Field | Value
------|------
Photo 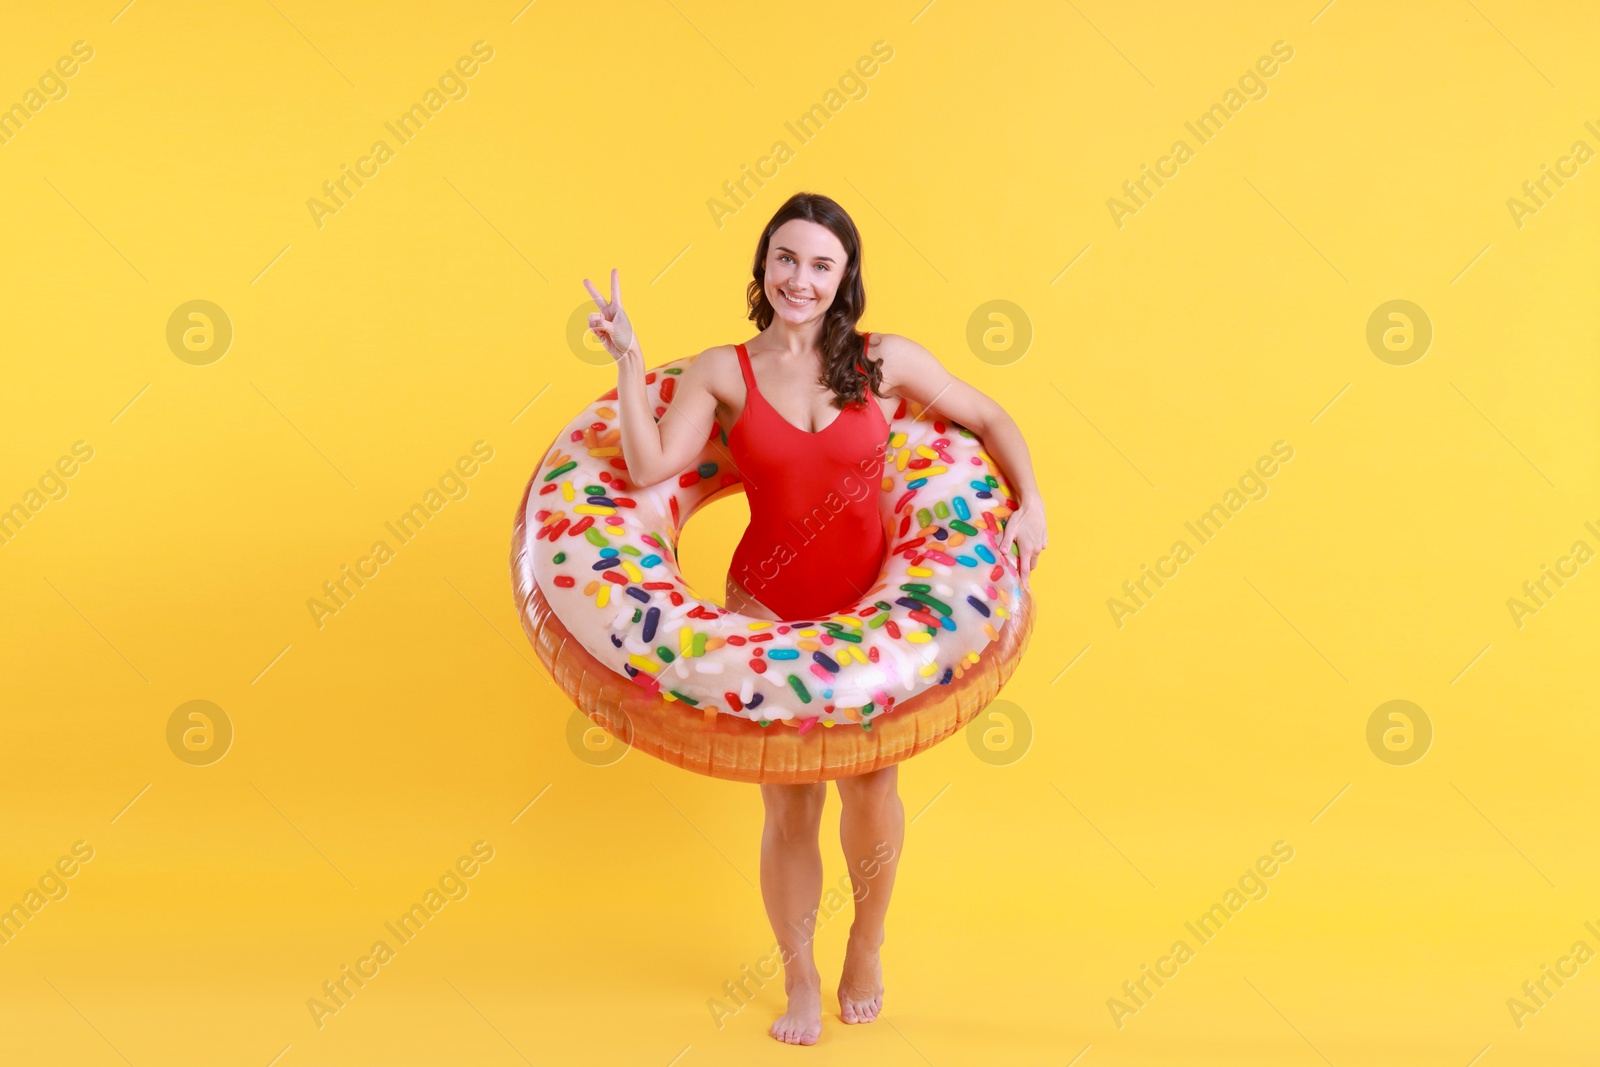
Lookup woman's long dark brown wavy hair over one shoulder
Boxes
[746,192,883,408]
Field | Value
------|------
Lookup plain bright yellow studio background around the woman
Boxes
[0,0,1600,1067]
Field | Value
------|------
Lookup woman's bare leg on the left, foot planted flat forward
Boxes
[762,782,827,1045]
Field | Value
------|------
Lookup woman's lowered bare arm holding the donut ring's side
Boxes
[874,333,1050,587]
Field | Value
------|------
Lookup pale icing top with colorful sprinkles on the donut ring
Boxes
[525,360,1021,734]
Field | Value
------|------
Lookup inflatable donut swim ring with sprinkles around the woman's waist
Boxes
[510,360,1034,784]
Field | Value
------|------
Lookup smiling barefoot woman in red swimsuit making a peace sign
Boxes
[584,194,1048,1045]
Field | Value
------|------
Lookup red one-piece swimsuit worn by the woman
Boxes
[728,334,890,622]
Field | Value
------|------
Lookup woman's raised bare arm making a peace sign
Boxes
[584,269,717,486]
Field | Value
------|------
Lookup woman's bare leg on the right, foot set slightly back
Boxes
[838,763,906,1022]
